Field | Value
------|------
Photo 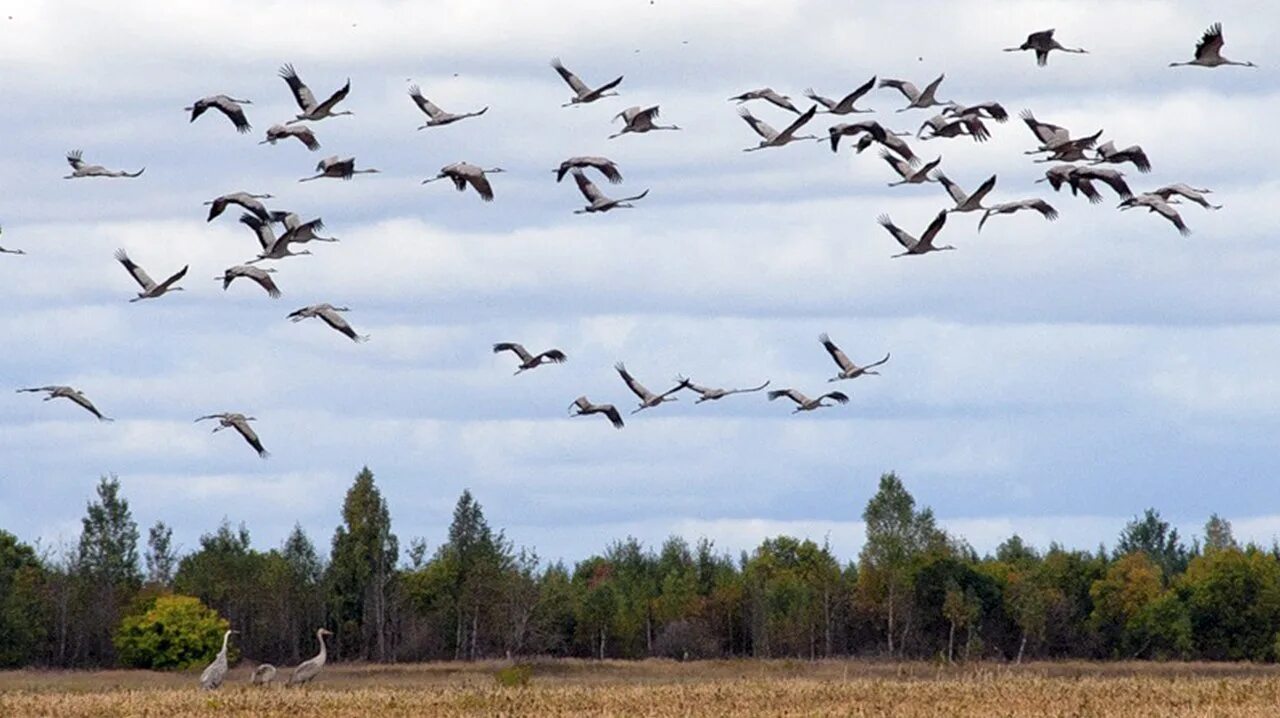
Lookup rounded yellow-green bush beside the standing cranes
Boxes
[114,595,229,669]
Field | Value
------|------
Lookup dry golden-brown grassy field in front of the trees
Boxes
[0,660,1280,718]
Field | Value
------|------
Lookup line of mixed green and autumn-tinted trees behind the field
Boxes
[0,468,1280,667]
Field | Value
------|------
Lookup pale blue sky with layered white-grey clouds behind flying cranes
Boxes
[0,0,1280,559]
